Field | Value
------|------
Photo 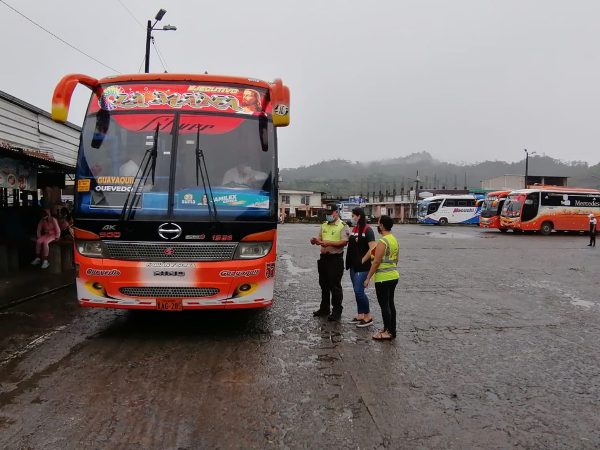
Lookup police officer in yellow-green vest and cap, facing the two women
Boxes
[310,205,350,321]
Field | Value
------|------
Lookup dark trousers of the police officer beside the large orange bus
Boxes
[317,253,344,315]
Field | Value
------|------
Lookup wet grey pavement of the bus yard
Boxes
[0,225,600,449]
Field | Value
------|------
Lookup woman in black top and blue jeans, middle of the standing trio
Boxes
[346,208,377,328]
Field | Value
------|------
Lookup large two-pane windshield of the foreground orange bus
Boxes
[76,82,276,220]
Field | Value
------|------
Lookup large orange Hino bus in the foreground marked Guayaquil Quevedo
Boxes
[52,73,289,311]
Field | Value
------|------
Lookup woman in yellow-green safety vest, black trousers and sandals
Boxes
[364,216,400,341]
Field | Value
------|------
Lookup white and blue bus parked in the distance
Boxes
[418,194,479,225]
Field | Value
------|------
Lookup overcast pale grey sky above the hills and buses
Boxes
[0,0,600,167]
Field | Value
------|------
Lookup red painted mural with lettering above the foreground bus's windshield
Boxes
[90,84,266,114]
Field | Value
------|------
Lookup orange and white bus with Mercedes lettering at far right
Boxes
[500,186,600,235]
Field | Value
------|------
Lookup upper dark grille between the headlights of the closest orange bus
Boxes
[103,241,237,261]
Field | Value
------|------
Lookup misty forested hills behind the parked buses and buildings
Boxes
[280,152,600,196]
